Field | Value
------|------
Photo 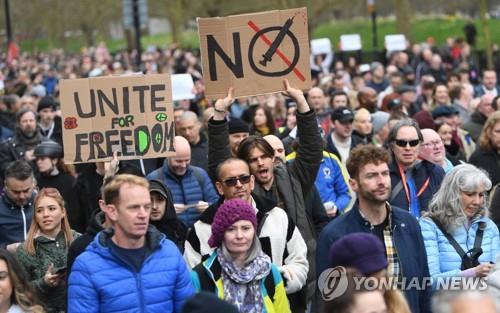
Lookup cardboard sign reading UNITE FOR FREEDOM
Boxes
[60,74,175,163]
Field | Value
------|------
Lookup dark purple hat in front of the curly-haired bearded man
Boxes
[329,233,387,275]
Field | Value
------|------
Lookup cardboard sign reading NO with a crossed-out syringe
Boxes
[198,8,311,99]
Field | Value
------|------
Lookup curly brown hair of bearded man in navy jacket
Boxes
[347,145,391,178]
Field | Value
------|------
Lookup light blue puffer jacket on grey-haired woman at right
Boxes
[420,216,500,279]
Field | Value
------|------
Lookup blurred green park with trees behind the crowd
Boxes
[0,0,500,67]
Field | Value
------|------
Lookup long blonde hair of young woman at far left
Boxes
[24,188,73,255]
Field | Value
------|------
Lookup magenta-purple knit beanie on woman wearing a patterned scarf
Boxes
[208,199,257,248]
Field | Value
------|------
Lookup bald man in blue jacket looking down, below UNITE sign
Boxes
[147,136,219,227]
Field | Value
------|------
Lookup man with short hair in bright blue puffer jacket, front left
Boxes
[68,174,194,313]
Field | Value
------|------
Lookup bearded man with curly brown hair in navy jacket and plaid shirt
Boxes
[316,145,430,313]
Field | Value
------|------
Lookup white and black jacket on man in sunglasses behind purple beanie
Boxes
[184,196,309,293]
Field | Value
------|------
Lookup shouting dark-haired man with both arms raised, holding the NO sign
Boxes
[208,80,323,312]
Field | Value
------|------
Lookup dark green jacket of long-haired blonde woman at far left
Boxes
[16,231,79,312]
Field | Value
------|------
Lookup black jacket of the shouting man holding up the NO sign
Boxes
[208,110,327,302]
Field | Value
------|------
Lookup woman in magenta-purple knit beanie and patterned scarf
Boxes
[191,199,290,313]
